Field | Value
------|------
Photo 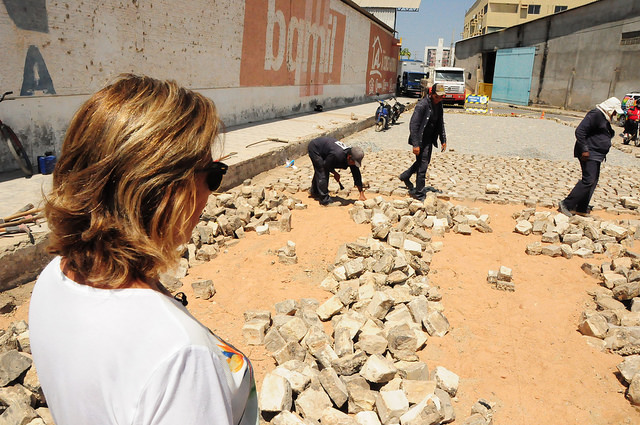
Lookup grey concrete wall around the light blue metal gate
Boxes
[455,0,640,110]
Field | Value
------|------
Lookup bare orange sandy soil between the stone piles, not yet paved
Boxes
[5,193,640,425]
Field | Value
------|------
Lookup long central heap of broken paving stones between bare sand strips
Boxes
[243,194,494,425]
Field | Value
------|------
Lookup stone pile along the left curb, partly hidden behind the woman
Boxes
[0,180,304,425]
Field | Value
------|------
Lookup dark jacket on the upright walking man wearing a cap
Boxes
[409,95,447,147]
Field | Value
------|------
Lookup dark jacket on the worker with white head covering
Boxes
[573,109,615,162]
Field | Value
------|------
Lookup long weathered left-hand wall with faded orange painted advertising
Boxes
[0,0,398,172]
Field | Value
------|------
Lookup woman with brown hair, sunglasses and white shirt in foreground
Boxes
[29,75,258,425]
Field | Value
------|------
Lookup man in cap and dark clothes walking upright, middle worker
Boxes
[400,83,447,201]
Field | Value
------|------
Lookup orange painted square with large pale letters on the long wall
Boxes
[240,0,346,97]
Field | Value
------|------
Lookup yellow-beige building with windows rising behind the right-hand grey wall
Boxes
[462,0,597,39]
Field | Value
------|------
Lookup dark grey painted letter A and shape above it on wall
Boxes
[2,0,56,96]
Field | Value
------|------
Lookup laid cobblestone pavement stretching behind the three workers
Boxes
[314,111,640,213]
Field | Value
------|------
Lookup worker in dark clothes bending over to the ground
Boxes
[309,136,367,205]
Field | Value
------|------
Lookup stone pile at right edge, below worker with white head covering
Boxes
[514,209,640,405]
